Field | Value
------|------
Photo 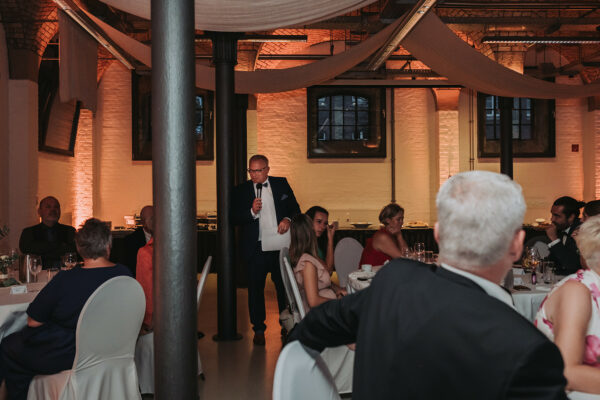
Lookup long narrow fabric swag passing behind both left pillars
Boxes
[88,10,400,93]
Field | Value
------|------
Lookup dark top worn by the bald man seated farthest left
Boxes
[19,223,77,268]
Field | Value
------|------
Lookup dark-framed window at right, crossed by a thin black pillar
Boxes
[477,93,555,158]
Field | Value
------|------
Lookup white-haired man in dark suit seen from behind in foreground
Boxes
[290,171,566,400]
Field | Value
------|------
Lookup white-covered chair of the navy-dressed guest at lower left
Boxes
[27,276,146,400]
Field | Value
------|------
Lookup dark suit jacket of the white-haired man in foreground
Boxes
[290,260,566,400]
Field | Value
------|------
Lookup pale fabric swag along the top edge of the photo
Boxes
[101,0,375,32]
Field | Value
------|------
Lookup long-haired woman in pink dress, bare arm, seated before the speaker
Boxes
[290,214,346,311]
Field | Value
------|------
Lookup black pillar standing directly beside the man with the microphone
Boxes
[211,32,241,340]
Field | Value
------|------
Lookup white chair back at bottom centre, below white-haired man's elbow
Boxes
[273,341,340,400]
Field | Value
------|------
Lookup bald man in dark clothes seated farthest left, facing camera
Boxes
[19,196,76,268]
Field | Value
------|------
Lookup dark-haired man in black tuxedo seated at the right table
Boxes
[546,196,585,275]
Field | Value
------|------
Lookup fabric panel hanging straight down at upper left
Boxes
[58,10,98,112]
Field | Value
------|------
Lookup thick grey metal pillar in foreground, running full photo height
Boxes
[152,0,198,400]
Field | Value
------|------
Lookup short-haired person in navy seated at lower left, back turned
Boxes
[0,218,131,400]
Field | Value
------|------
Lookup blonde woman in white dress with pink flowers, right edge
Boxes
[534,216,600,393]
